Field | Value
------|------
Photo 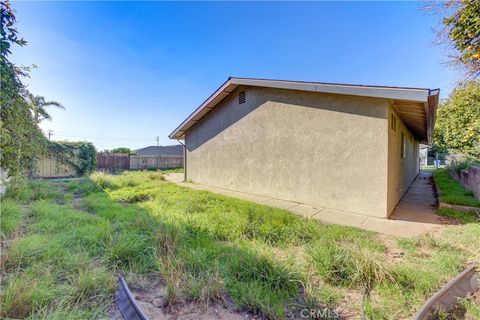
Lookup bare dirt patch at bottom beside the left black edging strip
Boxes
[108,277,256,320]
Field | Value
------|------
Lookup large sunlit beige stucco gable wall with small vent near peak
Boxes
[185,87,389,217]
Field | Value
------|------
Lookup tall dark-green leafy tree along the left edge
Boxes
[0,1,46,175]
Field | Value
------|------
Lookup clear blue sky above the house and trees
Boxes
[12,2,459,150]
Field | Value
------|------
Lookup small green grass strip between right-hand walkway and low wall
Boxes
[433,169,480,207]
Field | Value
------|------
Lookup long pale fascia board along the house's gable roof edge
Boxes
[169,77,431,140]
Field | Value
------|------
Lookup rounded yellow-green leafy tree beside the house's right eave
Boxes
[434,81,480,159]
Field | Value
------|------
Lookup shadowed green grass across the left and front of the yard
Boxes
[1,179,330,319]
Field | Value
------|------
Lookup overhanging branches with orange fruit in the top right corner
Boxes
[429,0,480,79]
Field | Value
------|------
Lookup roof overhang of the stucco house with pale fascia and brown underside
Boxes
[169,78,439,143]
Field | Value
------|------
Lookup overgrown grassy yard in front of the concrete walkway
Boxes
[0,172,480,319]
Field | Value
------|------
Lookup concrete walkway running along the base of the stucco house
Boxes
[165,173,441,237]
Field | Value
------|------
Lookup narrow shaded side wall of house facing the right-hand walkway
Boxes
[387,106,420,215]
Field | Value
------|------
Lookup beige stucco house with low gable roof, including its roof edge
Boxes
[170,78,439,218]
